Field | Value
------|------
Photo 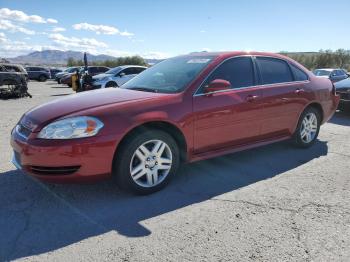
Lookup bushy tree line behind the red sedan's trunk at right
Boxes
[280,49,350,71]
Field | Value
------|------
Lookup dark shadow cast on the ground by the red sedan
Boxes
[0,141,328,260]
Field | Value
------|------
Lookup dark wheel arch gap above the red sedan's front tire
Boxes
[113,120,188,165]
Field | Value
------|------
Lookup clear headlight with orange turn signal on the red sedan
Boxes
[38,116,103,139]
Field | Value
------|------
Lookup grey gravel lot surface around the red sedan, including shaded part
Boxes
[0,82,350,261]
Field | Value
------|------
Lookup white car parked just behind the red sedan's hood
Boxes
[92,65,147,89]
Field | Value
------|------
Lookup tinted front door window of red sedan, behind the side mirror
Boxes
[204,57,254,89]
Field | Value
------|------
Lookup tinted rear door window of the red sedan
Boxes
[256,57,293,85]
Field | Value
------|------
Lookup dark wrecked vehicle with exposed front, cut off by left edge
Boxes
[0,63,31,98]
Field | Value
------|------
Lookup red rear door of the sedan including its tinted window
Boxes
[255,56,308,138]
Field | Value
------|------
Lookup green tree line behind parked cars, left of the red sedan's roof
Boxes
[67,56,147,68]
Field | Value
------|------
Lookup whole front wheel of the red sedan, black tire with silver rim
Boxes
[113,130,180,195]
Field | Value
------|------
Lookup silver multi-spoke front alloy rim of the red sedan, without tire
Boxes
[130,140,172,187]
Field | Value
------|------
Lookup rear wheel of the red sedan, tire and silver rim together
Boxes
[293,107,321,148]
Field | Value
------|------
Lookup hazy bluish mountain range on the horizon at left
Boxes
[6,50,160,65]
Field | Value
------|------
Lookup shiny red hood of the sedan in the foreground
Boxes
[21,88,164,132]
